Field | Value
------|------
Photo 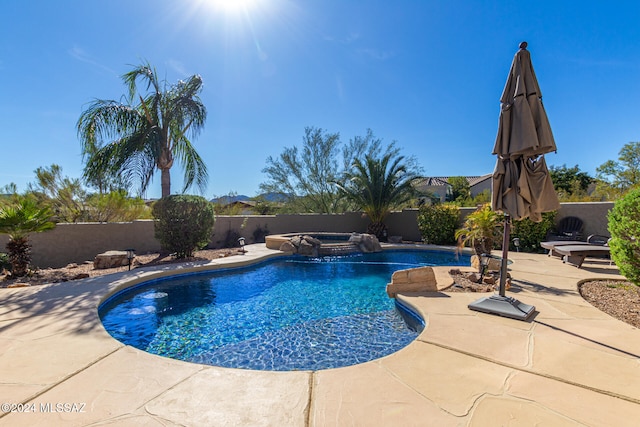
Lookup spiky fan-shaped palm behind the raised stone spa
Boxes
[337,150,417,240]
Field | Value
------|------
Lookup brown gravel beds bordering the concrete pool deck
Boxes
[0,249,640,328]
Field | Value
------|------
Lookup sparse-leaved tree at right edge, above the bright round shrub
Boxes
[596,142,640,198]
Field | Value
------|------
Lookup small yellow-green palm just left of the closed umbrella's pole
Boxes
[455,204,502,256]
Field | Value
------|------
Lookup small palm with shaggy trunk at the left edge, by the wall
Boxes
[0,198,56,277]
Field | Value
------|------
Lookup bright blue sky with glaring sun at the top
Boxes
[0,0,640,198]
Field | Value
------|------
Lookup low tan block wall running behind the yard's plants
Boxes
[0,202,613,268]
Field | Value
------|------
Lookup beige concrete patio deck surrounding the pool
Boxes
[0,245,640,427]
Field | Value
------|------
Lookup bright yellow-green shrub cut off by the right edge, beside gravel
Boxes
[608,189,640,285]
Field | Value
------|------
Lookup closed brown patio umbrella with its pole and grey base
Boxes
[469,42,560,320]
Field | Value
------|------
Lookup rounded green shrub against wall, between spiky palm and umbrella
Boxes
[418,204,460,245]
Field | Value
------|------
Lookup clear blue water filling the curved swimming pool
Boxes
[99,251,469,371]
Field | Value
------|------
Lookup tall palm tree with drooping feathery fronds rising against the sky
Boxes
[77,63,208,197]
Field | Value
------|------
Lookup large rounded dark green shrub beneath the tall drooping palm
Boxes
[153,195,215,258]
